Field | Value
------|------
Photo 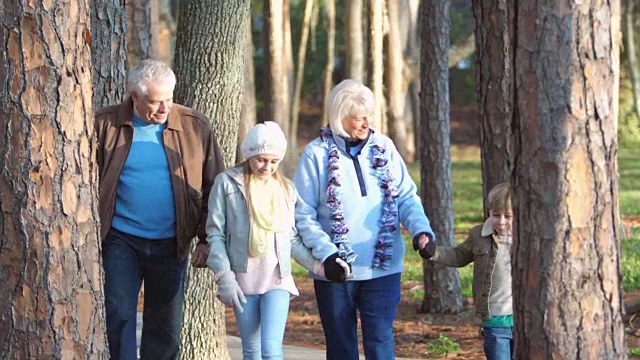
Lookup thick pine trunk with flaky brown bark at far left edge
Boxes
[0,0,108,359]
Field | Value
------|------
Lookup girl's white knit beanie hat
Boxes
[240,121,287,160]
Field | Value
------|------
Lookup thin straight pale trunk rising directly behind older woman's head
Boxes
[368,0,387,133]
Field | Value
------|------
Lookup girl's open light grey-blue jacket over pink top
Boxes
[207,163,316,277]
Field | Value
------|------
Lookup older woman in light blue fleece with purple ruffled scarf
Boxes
[294,80,435,360]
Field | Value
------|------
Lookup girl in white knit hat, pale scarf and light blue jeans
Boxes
[207,121,348,360]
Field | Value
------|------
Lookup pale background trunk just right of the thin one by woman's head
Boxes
[385,1,413,161]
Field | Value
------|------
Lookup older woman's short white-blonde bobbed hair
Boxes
[325,79,375,138]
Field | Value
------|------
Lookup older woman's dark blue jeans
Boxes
[314,273,401,360]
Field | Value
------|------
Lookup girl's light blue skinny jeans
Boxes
[234,289,291,360]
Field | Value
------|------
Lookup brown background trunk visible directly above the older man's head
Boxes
[125,0,159,69]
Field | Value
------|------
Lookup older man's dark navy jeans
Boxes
[102,228,186,360]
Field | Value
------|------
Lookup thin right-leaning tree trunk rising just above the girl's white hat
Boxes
[289,0,315,155]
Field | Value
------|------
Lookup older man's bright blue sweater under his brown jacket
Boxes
[111,115,176,239]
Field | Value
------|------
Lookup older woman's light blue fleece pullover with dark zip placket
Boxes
[293,131,435,281]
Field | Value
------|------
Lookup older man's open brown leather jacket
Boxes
[95,98,224,259]
